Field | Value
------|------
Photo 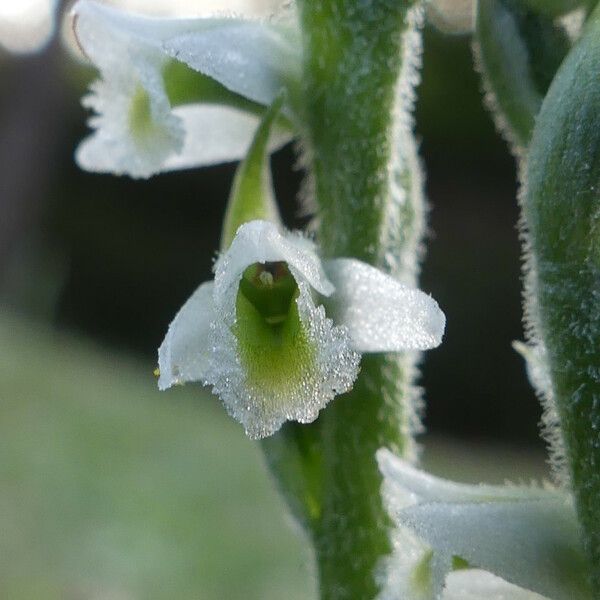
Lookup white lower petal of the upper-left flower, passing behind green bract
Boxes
[163,104,291,171]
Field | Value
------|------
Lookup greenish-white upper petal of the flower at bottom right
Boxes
[377,450,586,600]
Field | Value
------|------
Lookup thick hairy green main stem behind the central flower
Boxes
[300,0,423,599]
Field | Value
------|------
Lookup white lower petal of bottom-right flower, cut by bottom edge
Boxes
[442,569,547,600]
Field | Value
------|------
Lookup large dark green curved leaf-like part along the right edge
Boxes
[523,7,600,597]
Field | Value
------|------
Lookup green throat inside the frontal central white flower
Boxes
[233,262,315,395]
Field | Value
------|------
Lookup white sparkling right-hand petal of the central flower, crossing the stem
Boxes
[326,258,446,352]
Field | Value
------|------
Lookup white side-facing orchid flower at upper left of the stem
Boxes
[73,0,300,177]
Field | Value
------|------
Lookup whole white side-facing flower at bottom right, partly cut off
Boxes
[377,449,590,600]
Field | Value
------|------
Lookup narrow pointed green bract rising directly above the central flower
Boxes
[221,95,283,250]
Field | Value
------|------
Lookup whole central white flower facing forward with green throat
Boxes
[158,221,445,438]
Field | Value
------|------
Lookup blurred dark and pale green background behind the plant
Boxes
[0,17,545,600]
